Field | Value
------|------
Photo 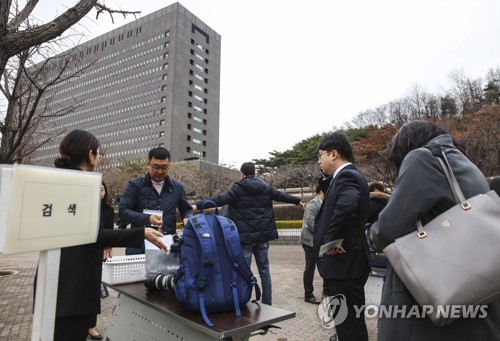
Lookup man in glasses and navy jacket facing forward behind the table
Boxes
[119,147,193,255]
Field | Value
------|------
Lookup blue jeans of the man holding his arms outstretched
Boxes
[241,242,272,305]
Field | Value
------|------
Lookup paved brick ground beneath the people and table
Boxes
[0,245,377,341]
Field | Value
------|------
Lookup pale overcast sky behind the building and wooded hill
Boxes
[35,0,500,167]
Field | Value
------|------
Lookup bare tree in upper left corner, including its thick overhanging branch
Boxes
[0,0,140,163]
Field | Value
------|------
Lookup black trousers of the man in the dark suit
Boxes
[327,276,368,341]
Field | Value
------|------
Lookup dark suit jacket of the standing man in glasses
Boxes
[314,164,370,280]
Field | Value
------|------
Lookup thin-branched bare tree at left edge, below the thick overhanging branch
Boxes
[0,41,97,163]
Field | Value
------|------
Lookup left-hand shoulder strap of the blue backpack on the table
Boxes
[189,214,217,327]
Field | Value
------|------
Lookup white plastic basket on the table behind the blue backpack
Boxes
[102,255,146,284]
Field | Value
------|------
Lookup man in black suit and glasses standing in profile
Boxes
[314,133,370,341]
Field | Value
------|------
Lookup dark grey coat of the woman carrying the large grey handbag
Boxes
[371,135,500,341]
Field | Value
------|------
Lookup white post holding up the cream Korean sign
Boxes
[31,249,61,341]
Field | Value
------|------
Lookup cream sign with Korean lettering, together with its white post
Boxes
[0,165,102,341]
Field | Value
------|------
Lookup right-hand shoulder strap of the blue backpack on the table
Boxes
[216,215,261,310]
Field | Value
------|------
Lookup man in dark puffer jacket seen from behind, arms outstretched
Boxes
[196,162,304,305]
